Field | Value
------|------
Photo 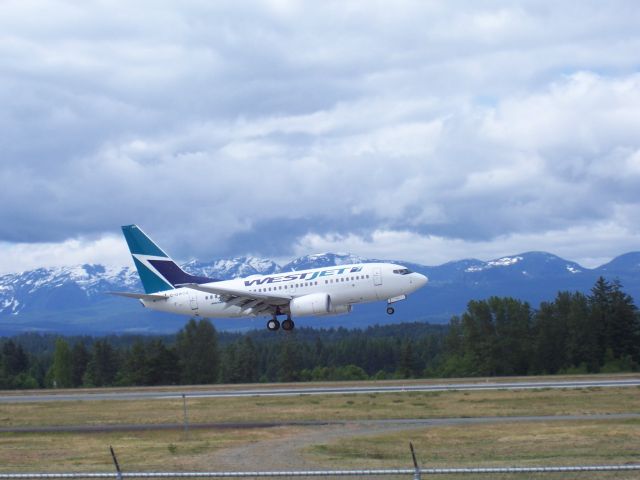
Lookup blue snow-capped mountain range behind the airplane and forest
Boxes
[0,252,640,335]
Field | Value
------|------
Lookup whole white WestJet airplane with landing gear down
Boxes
[110,225,428,331]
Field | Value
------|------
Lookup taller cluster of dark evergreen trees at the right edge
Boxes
[434,277,640,376]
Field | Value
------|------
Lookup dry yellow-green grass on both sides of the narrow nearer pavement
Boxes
[0,376,640,479]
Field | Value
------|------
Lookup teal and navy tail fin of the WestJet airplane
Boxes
[122,225,216,294]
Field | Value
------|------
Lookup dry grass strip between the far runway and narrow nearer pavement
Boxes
[0,387,640,427]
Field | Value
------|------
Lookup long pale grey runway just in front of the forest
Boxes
[0,378,640,403]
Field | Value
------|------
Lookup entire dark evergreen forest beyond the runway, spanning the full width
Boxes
[0,278,640,389]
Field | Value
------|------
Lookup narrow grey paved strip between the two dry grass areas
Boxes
[0,413,640,433]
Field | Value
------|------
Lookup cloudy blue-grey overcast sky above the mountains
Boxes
[0,0,640,273]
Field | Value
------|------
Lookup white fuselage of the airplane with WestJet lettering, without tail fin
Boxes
[140,263,427,318]
